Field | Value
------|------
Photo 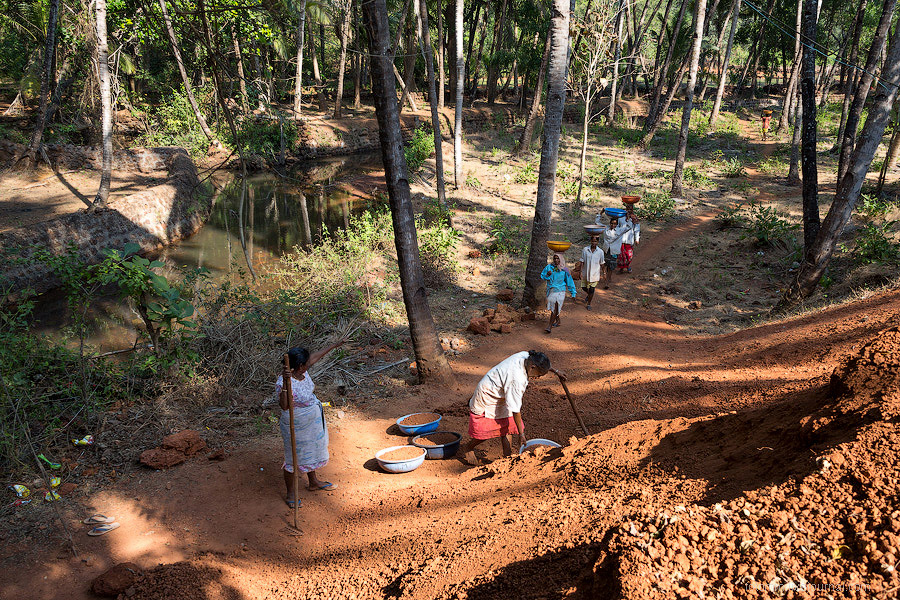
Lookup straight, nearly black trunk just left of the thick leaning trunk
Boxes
[800,0,821,252]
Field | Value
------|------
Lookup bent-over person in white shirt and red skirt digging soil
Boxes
[461,350,550,466]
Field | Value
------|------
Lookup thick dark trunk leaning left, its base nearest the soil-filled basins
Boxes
[363,0,453,383]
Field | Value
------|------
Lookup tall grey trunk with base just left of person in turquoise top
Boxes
[522,0,570,308]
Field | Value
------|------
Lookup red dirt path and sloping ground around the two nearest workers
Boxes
[0,215,900,600]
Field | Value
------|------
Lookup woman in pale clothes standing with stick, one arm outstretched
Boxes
[275,340,345,508]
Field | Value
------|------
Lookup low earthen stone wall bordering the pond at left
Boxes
[0,148,212,293]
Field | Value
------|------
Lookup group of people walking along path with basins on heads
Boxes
[541,208,641,333]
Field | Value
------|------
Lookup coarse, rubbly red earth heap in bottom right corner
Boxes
[595,329,900,598]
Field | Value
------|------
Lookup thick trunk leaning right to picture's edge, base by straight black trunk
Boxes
[776,22,900,310]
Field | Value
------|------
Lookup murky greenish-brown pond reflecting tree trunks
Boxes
[27,154,384,352]
